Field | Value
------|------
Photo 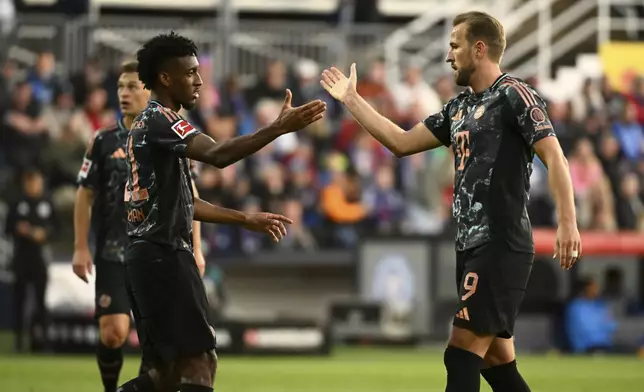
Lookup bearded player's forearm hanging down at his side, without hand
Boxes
[548,155,577,224]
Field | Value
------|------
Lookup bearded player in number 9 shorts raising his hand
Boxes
[320,12,581,392]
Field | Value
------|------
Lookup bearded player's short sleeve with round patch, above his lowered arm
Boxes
[506,81,555,148]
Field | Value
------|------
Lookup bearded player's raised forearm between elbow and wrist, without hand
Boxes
[344,89,405,155]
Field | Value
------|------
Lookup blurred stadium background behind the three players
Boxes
[0,0,644,392]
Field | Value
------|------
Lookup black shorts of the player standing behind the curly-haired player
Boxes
[94,259,130,320]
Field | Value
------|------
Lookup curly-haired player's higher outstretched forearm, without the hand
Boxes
[206,127,282,169]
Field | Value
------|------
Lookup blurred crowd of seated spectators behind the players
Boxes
[0,52,644,254]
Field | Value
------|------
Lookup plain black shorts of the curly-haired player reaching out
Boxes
[125,240,216,366]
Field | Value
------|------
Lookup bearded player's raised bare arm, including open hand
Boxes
[320,64,449,157]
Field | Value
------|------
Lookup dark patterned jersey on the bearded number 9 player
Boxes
[423,74,555,253]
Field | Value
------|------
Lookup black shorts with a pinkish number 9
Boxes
[453,242,534,339]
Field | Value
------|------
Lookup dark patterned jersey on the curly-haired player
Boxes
[125,101,199,252]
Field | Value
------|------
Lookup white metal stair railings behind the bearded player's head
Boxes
[385,0,644,82]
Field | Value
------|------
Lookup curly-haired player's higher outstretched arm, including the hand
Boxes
[185,90,326,169]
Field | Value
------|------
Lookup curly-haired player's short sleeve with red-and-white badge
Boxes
[146,109,200,156]
